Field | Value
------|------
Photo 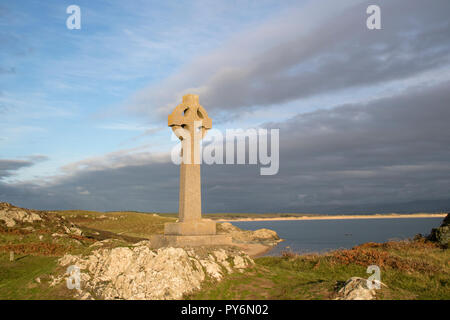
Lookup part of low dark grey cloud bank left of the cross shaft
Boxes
[0,163,178,212]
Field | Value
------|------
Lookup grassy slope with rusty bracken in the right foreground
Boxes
[186,241,450,300]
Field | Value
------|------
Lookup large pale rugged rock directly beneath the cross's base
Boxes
[53,241,254,299]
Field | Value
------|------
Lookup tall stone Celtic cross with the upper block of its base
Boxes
[164,94,216,235]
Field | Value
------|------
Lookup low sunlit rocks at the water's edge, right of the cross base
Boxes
[217,222,282,246]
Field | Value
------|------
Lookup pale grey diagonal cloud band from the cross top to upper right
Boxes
[128,0,450,120]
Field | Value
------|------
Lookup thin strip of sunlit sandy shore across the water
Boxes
[214,213,447,222]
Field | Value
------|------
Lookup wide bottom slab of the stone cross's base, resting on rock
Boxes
[150,234,232,248]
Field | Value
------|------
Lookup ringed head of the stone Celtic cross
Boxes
[168,94,212,140]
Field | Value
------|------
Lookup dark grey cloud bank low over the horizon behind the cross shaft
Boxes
[0,82,450,213]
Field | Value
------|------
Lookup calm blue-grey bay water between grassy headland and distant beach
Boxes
[233,218,442,255]
